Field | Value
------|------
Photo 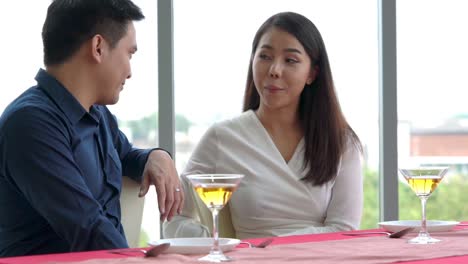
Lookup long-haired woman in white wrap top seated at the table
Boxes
[165,12,363,239]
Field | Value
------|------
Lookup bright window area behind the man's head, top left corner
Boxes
[0,0,50,112]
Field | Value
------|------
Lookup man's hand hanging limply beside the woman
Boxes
[139,150,184,221]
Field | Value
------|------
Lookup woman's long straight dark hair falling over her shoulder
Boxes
[243,12,362,185]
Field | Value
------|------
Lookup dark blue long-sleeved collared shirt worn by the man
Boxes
[0,69,151,256]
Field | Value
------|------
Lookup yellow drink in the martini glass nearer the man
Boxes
[195,183,237,209]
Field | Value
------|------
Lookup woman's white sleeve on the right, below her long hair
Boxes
[282,140,363,236]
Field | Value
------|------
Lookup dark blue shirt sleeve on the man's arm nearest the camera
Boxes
[4,107,128,251]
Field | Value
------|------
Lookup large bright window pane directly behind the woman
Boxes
[174,0,379,228]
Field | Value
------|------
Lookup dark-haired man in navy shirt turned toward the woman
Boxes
[0,0,184,256]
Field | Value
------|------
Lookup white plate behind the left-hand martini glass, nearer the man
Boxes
[148,237,240,254]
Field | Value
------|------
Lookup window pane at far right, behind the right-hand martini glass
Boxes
[397,0,468,220]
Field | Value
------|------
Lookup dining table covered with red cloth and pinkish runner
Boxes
[0,222,468,264]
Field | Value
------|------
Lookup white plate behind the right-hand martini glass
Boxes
[379,220,460,233]
